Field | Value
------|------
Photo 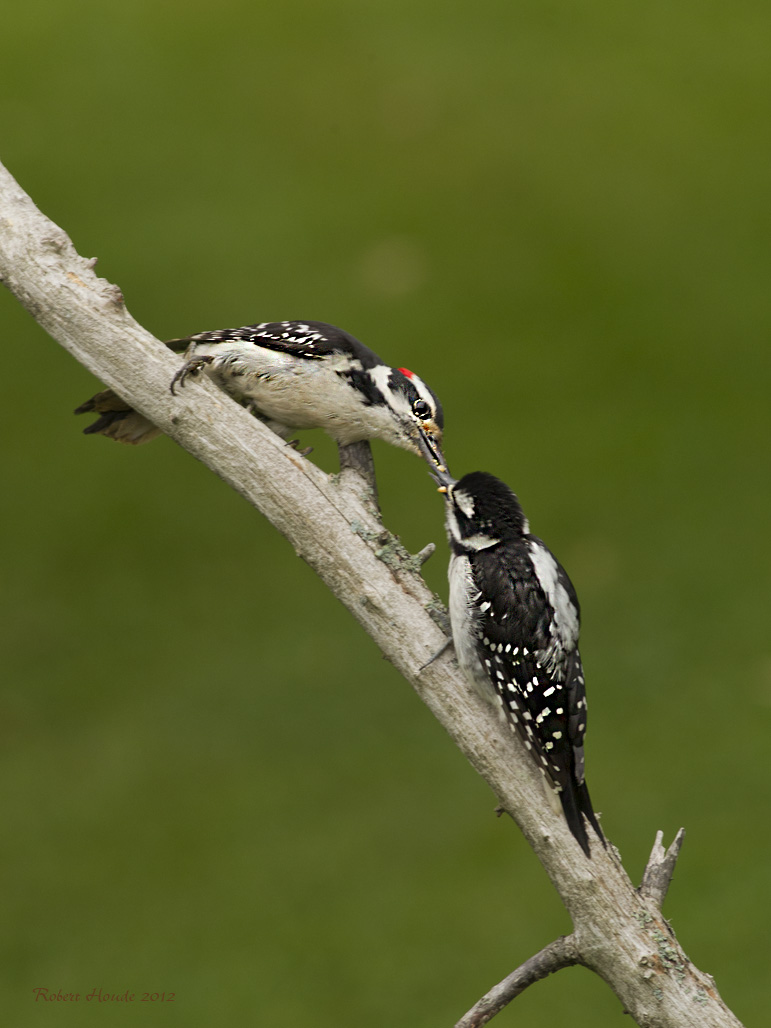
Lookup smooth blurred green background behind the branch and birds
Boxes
[0,0,771,1028]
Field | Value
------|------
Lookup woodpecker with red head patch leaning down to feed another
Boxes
[75,321,444,464]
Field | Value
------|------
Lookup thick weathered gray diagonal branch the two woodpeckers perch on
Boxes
[0,154,739,1028]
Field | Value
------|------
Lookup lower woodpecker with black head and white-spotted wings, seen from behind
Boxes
[434,471,604,857]
